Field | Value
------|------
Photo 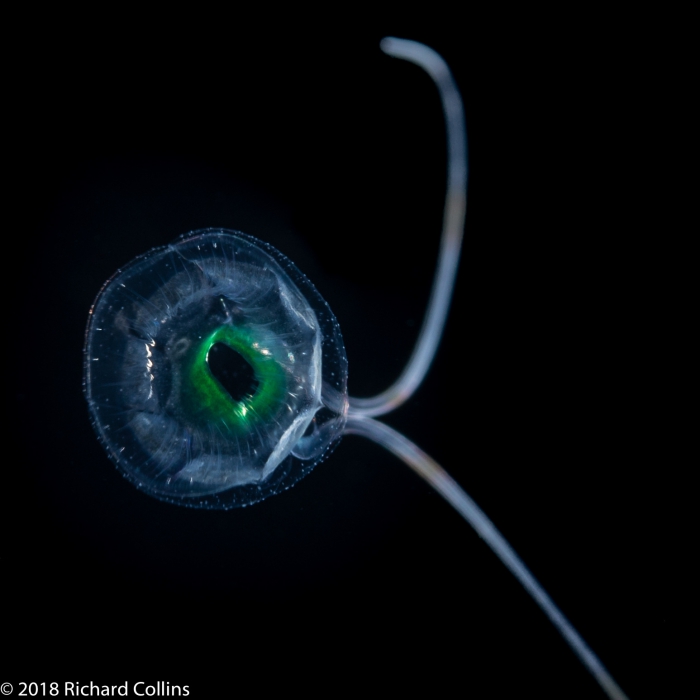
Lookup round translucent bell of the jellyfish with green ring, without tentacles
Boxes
[84,229,348,508]
